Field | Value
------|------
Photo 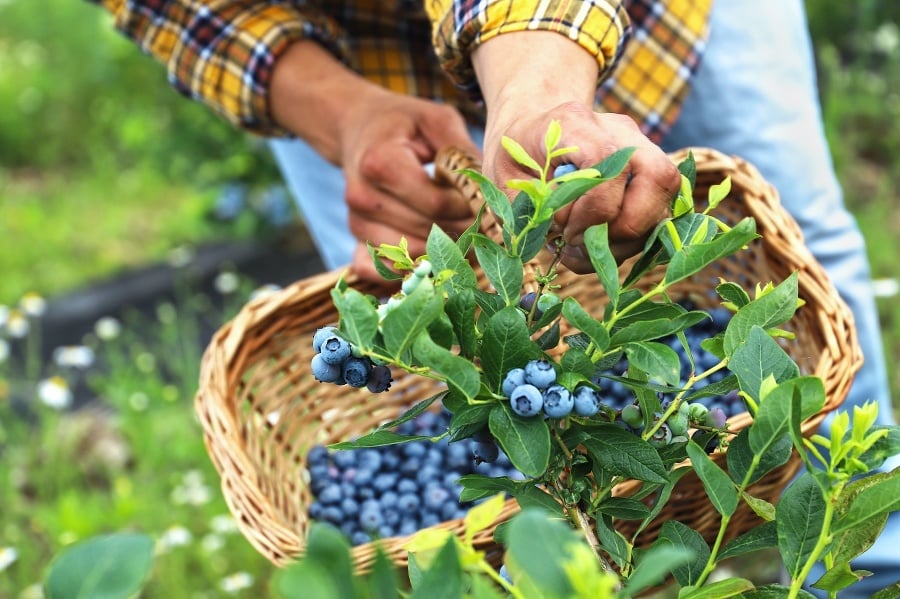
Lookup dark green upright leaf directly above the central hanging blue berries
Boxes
[480,307,540,391]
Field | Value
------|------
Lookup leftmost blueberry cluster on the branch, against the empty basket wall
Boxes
[310,326,391,393]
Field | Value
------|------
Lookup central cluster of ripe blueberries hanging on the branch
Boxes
[501,359,600,418]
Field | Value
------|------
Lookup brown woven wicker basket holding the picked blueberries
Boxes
[196,148,862,571]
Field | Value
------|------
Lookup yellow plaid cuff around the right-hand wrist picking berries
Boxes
[426,0,628,95]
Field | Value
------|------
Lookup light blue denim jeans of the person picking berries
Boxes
[271,0,900,597]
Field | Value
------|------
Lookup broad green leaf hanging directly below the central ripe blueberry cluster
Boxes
[488,402,548,478]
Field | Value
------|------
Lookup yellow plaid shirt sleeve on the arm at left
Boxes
[85,0,348,135]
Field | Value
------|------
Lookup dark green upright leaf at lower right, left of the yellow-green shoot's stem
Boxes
[775,472,825,579]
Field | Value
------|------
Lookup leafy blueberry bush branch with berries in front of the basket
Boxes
[312,122,900,597]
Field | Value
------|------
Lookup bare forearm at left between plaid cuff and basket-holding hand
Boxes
[269,40,388,164]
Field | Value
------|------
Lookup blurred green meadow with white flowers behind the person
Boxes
[0,0,900,597]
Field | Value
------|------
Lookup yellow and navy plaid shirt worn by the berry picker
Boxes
[89,0,712,141]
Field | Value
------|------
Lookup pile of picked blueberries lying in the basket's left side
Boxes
[307,412,522,545]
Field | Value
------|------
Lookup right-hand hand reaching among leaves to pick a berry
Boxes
[483,102,681,273]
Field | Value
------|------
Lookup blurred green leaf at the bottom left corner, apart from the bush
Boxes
[44,533,153,599]
